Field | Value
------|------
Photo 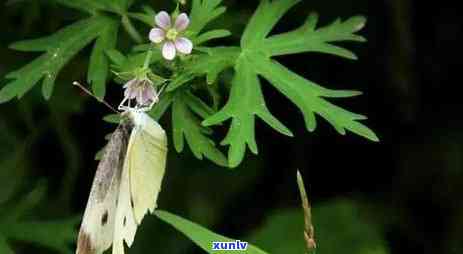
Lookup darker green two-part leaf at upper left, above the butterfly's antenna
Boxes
[0,16,117,102]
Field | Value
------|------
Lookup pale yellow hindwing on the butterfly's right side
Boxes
[128,113,167,224]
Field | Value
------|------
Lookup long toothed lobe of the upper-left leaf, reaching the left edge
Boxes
[0,16,118,103]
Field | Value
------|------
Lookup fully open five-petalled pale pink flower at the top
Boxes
[149,11,193,60]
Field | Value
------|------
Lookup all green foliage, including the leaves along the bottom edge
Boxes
[0,0,385,251]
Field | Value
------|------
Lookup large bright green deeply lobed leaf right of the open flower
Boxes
[205,0,379,167]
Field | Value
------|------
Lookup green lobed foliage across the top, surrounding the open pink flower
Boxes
[0,0,378,167]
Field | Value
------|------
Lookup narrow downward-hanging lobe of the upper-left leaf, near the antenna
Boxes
[87,18,119,99]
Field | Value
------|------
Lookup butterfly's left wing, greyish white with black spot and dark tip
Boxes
[76,125,129,254]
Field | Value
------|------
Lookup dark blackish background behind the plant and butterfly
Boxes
[0,0,463,254]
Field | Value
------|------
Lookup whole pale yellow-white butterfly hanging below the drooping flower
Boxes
[76,81,167,254]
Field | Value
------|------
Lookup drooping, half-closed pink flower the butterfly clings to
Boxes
[124,78,158,107]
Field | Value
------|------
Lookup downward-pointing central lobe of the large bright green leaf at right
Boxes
[203,58,293,167]
